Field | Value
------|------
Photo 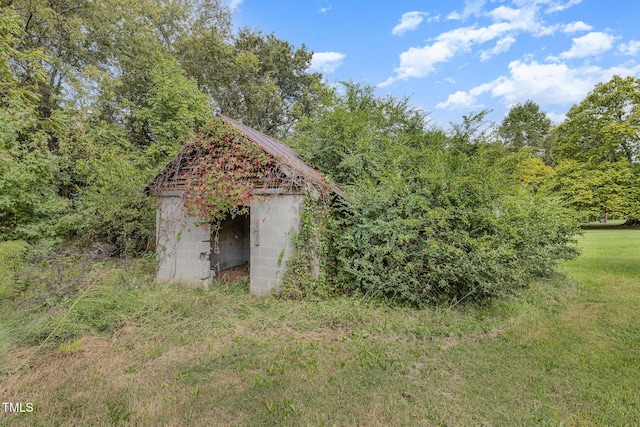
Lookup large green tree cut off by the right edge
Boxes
[552,76,640,224]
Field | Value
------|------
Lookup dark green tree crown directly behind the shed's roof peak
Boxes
[177,28,324,137]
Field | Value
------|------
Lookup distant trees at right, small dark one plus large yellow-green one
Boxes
[498,76,640,226]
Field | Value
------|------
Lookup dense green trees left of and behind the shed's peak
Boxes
[0,0,323,254]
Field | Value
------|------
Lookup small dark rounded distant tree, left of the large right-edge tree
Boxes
[498,100,551,160]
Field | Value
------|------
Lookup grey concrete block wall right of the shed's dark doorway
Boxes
[250,195,304,295]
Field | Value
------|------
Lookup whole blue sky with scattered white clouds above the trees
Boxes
[230,0,640,127]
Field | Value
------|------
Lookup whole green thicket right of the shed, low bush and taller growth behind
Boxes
[298,85,576,306]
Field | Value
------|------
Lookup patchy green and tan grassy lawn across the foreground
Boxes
[0,229,640,426]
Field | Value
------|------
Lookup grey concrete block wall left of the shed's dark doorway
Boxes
[156,196,211,286]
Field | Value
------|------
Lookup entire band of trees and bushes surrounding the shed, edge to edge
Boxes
[0,0,640,305]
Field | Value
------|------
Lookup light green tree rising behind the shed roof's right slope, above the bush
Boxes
[291,83,432,185]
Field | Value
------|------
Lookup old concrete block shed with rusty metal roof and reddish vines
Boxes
[145,114,343,295]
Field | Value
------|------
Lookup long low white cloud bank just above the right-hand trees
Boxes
[436,61,640,113]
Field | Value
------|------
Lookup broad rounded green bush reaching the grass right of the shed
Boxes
[334,150,577,307]
